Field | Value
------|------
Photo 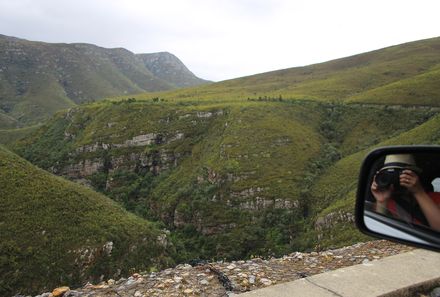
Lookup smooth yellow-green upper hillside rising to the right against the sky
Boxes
[130,38,440,106]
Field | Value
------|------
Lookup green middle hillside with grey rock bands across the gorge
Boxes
[15,100,435,261]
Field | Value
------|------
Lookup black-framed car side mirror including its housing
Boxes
[355,146,440,251]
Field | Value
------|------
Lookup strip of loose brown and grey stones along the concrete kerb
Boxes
[33,240,412,297]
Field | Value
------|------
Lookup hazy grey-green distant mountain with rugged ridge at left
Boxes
[0,35,207,127]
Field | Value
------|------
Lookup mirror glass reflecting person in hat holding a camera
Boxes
[364,153,440,246]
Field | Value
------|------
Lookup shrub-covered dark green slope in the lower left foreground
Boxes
[0,146,170,296]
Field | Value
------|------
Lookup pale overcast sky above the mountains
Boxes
[0,0,440,81]
